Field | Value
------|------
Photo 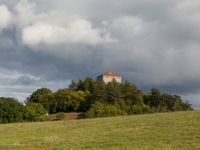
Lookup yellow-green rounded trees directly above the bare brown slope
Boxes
[38,89,92,113]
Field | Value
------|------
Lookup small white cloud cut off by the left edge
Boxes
[0,5,12,31]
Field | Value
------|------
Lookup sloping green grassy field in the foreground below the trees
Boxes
[0,110,200,150]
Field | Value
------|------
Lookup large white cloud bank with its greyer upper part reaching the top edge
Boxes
[10,0,118,47]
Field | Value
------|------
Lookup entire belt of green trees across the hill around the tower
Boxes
[0,77,192,123]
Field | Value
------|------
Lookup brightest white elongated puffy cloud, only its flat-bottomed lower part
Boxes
[22,19,117,46]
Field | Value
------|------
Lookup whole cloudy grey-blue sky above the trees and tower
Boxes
[0,0,200,109]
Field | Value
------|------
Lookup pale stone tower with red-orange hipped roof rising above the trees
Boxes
[97,71,122,83]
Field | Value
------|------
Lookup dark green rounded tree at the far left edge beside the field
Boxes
[0,97,24,123]
